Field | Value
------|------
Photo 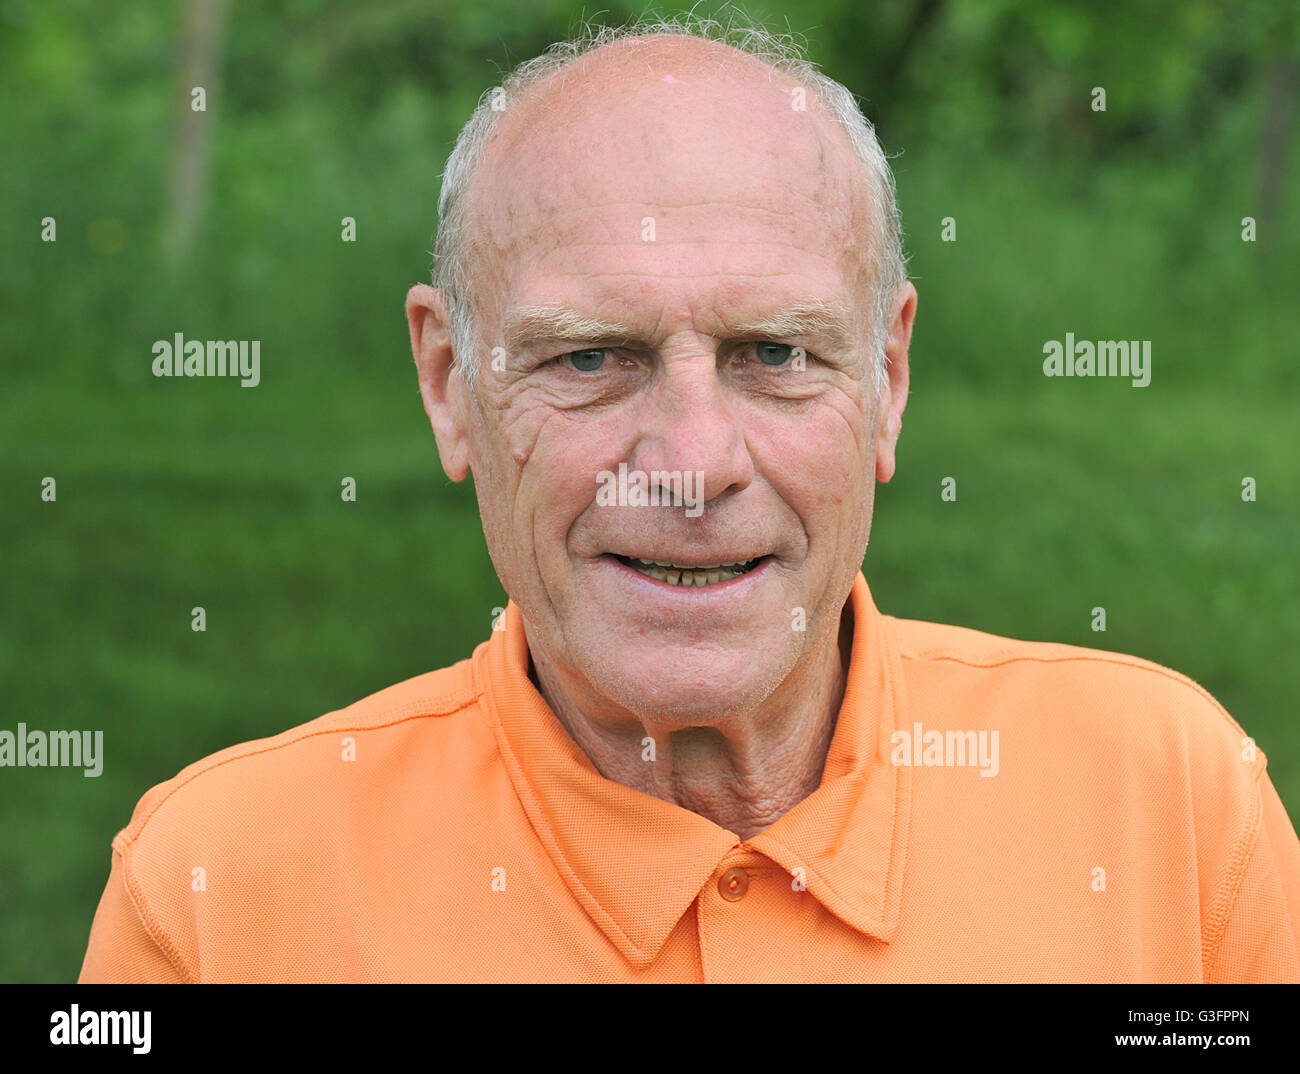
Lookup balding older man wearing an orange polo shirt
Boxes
[82,26,1300,982]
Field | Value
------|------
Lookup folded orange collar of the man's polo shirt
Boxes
[473,572,911,969]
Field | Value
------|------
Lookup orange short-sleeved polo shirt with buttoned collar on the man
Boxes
[81,575,1300,982]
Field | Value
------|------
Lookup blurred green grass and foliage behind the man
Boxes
[0,0,1300,980]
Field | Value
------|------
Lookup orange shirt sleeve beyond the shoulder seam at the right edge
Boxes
[1206,771,1300,983]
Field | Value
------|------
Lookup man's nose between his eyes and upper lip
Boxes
[628,346,754,504]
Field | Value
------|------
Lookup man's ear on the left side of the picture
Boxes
[407,283,469,481]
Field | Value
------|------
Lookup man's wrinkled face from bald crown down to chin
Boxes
[416,43,914,723]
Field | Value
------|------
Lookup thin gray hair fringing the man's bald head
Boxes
[433,12,907,394]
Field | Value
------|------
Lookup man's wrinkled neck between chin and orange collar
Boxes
[533,605,853,840]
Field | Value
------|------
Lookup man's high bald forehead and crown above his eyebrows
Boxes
[471,39,868,322]
